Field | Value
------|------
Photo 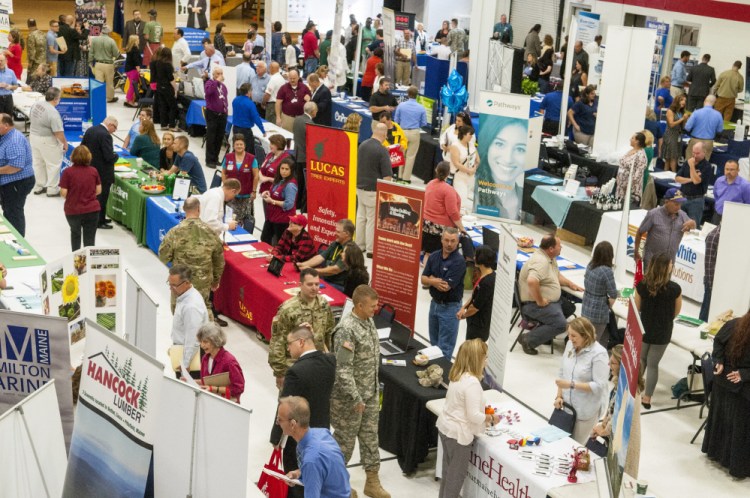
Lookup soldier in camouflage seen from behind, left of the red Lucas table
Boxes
[159,197,224,320]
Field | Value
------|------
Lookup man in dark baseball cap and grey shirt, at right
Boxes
[633,188,696,270]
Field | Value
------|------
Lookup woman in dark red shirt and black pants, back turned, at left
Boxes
[60,145,102,251]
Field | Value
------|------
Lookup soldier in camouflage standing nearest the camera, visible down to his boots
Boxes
[331,285,391,498]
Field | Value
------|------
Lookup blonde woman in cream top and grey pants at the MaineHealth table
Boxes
[437,339,500,498]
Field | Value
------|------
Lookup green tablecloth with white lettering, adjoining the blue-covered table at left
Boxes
[107,158,163,245]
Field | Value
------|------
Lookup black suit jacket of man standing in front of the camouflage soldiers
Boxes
[271,351,336,444]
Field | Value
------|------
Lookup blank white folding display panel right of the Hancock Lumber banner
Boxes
[154,378,253,498]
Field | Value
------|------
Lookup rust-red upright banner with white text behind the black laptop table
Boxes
[371,180,424,330]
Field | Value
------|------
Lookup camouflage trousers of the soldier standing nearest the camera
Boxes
[331,395,380,472]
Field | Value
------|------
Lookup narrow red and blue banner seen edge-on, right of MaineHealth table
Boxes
[607,297,643,496]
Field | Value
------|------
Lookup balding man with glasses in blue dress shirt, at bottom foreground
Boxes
[276,396,354,498]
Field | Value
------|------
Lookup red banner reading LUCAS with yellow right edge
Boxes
[307,124,357,244]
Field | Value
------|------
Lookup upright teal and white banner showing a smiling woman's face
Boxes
[474,91,536,221]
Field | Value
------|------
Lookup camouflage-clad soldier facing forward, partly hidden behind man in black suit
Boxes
[268,268,334,389]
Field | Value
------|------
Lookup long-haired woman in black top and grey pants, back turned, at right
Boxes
[635,253,682,410]
